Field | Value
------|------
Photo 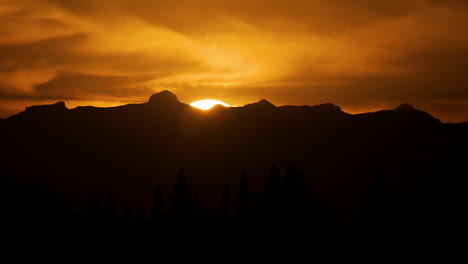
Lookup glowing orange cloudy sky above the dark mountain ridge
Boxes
[0,0,468,122]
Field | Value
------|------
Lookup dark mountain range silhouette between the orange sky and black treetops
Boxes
[0,91,468,221]
